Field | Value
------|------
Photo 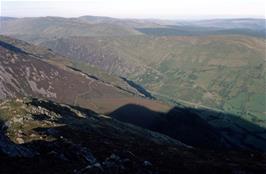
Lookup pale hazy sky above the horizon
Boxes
[0,0,266,19]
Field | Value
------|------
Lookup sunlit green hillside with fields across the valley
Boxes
[41,35,266,126]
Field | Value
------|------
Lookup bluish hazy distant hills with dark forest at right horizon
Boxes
[137,19,266,38]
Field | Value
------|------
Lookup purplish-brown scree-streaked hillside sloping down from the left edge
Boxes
[0,36,169,113]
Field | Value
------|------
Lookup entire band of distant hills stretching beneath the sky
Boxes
[0,16,266,43]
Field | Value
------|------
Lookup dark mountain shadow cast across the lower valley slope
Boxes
[110,104,266,151]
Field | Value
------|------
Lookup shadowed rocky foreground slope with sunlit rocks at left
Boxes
[0,98,266,174]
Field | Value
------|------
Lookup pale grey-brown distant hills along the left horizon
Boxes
[0,17,141,43]
